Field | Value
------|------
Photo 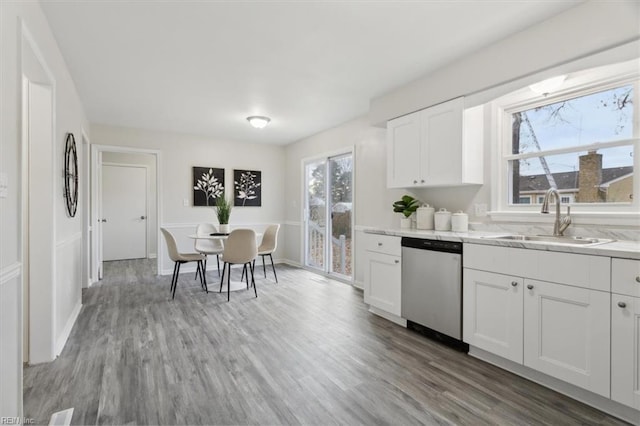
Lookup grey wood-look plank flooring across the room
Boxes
[24,260,625,425]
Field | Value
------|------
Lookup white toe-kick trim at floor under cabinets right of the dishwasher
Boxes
[469,346,640,424]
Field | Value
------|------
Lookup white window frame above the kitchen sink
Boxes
[489,59,640,226]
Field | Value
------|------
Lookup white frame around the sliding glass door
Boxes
[300,145,356,285]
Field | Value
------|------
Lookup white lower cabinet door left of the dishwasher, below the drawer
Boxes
[364,251,401,316]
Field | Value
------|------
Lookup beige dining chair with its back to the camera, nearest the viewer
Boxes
[220,229,258,301]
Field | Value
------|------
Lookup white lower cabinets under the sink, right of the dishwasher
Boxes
[463,244,624,409]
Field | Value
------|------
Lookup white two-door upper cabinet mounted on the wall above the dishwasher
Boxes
[387,98,484,188]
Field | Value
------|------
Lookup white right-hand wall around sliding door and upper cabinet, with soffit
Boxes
[286,2,640,282]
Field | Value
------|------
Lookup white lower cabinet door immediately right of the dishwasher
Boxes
[462,268,523,364]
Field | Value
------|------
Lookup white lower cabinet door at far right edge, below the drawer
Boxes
[611,294,640,410]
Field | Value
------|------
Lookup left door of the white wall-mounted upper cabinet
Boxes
[387,112,420,188]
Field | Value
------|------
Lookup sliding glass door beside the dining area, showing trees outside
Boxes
[304,152,353,280]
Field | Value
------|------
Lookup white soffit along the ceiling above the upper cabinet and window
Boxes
[369,0,640,126]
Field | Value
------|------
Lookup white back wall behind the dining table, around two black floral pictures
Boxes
[91,124,285,274]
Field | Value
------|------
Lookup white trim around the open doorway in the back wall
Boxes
[89,145,162,283]
